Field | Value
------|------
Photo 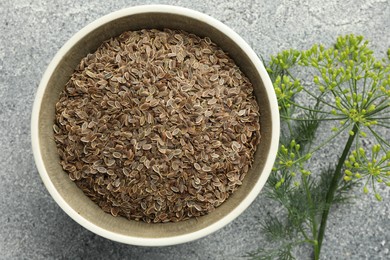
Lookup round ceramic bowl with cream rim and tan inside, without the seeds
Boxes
[31,5,279,246]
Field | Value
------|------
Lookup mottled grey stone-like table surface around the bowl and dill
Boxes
[0,0,390,259]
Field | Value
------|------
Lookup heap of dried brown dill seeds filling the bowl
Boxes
[53,29,260,223]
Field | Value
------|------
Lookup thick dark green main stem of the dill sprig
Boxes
[314,123,359,260]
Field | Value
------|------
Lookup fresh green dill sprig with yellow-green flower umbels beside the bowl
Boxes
[248,35,390,259]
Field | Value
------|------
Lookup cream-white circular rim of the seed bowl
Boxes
[31,5,280,246]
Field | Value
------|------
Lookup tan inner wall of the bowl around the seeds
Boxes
[38,12,272,238]
